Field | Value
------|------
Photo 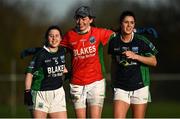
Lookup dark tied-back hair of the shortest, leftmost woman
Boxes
[44,25,62,46]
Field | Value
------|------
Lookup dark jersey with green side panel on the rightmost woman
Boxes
[108,34,157,91]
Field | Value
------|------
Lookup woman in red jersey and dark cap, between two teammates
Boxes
[61,6,113,118]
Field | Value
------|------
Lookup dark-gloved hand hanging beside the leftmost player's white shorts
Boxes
[24,90,33,106]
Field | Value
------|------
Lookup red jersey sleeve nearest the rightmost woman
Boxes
[100,29,114,45]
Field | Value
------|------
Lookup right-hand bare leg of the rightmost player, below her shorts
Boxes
[131,103,147,118]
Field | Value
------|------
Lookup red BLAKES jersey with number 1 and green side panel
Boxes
[61,27,113,85]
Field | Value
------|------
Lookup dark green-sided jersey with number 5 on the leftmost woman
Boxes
[26,47,65,91]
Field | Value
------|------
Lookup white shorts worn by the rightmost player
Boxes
[114,86,151,104]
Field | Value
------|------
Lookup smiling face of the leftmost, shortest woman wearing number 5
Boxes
[48,29,62,48]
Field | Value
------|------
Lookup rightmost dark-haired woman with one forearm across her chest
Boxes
[108,11,157,118]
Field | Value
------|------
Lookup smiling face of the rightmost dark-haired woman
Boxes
[121,16,135,35]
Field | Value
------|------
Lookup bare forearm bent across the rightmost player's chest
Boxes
[135,55,157,66]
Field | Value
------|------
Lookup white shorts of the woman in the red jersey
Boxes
[70,79,105,109]
